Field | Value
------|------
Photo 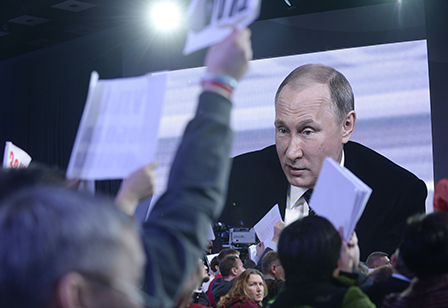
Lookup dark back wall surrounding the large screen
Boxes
[0,0,448,196]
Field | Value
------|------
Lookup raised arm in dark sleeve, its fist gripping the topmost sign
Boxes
[143,29,252,307]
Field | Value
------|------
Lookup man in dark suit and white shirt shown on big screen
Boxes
[220,64,427,260]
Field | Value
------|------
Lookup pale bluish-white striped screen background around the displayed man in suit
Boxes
[153,40,434,212]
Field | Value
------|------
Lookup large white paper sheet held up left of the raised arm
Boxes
[66,72,167,180]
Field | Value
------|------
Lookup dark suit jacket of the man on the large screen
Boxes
[219,142,427,260]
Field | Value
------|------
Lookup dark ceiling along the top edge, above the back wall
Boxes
[0,0,402,61]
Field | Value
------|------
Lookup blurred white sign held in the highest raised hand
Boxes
[183,0,261,55]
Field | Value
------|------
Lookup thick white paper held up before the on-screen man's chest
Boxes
[310,158,372,242]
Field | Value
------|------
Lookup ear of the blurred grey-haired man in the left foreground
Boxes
[54,272,88,308]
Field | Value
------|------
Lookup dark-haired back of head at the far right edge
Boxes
[400,212,448,277]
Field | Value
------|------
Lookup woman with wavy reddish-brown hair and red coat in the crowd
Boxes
[218,269,267,308]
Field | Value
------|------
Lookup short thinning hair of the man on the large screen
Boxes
[275,64,355,122]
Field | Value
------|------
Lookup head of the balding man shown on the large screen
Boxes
[274,64,356,188]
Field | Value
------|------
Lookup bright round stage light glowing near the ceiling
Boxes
[150,1,182,31]
